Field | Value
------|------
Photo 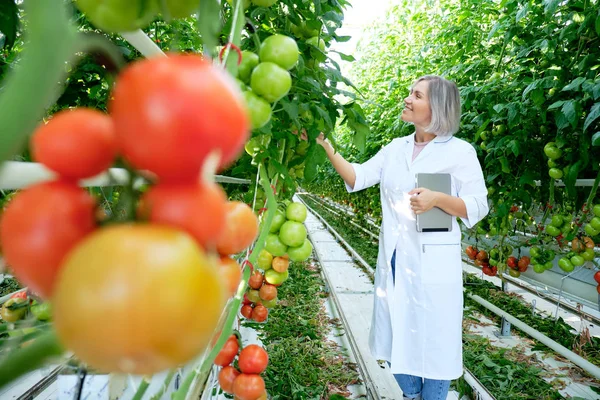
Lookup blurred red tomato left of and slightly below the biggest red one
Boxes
[31,108,117,179]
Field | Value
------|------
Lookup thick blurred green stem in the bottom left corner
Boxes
[0,330,64,388]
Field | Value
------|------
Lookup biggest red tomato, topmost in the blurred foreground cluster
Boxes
[109,54,250,181]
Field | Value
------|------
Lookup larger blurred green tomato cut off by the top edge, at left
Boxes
[75,0,158,32]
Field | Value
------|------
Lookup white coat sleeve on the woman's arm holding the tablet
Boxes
[455,145,489,228]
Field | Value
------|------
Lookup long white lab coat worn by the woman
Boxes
[347,134,489,380]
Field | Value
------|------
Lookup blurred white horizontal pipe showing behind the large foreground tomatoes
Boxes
[0,161,250,190]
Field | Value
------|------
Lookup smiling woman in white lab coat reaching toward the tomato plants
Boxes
[318,76,489,400]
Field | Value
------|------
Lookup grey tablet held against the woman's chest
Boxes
[416,174,452,232]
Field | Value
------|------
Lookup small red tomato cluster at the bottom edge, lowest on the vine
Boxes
[215,334,269,400]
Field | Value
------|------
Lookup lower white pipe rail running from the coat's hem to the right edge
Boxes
[466,293,600,379]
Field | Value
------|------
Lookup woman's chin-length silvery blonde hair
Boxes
[413,75,461,136]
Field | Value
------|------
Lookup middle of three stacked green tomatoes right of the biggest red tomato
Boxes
[250,62,292,103]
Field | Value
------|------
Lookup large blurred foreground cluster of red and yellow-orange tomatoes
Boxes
[0,55,258,374]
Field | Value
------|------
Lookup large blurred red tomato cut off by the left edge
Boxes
[0,181,96,298]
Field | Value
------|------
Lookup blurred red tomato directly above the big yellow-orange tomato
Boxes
[139,183,227,249]
